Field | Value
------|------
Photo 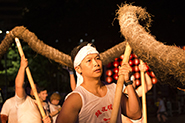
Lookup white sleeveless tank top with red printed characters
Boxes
[67,83,122,123]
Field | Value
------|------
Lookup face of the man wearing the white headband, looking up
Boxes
[79,54,102,78]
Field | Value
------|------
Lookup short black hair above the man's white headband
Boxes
[71,42,96,63]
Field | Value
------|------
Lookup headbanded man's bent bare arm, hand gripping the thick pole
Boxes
[119,63,141,120]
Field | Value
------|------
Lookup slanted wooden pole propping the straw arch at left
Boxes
[15,38,46,118]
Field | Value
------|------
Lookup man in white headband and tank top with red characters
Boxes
[56,42,142,123]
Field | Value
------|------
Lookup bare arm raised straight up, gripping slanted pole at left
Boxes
[15,56,28,98]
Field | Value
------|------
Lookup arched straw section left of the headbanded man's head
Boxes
[0,26,72,66]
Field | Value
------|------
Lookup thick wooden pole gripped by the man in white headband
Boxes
[110,42,131,123]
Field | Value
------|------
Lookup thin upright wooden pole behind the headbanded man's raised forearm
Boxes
[140,60,147,123]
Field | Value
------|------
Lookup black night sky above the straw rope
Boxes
[0,0,185,54]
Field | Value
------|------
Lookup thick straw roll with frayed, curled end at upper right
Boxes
[117,4,185,88]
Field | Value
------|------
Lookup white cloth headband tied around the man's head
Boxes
[74,44,99,87]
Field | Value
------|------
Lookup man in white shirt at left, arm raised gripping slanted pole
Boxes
[15,56,51,123]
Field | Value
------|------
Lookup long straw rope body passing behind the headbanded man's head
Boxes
[0,26,126,68]
